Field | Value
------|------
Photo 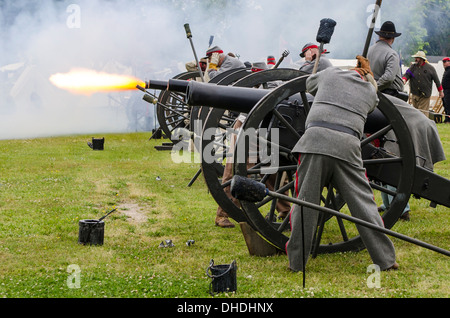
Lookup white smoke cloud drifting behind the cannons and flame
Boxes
[0,0,406,139]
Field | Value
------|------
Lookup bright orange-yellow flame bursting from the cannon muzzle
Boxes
[50,69,145,95]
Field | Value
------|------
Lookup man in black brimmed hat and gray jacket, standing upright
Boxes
[367,21,404,97]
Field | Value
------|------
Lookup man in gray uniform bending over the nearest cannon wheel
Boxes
[286,56,398,271]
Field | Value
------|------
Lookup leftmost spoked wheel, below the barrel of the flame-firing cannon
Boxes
[156,72,199,138]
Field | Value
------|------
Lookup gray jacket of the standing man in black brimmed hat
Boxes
[367,40,404,91]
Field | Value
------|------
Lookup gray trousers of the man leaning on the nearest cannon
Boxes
[286,154,395,271]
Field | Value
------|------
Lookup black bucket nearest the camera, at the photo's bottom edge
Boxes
[206,260,237,294]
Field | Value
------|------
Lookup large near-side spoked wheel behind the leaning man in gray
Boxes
[234,76,415,254]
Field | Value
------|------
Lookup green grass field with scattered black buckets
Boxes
[0,124,450,298]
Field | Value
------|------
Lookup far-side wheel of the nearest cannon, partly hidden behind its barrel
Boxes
[201,69,305,222]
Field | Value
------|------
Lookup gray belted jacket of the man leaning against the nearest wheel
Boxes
[292,67,378,167]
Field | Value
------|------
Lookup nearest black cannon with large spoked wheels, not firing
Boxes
[139,69,450,256]
